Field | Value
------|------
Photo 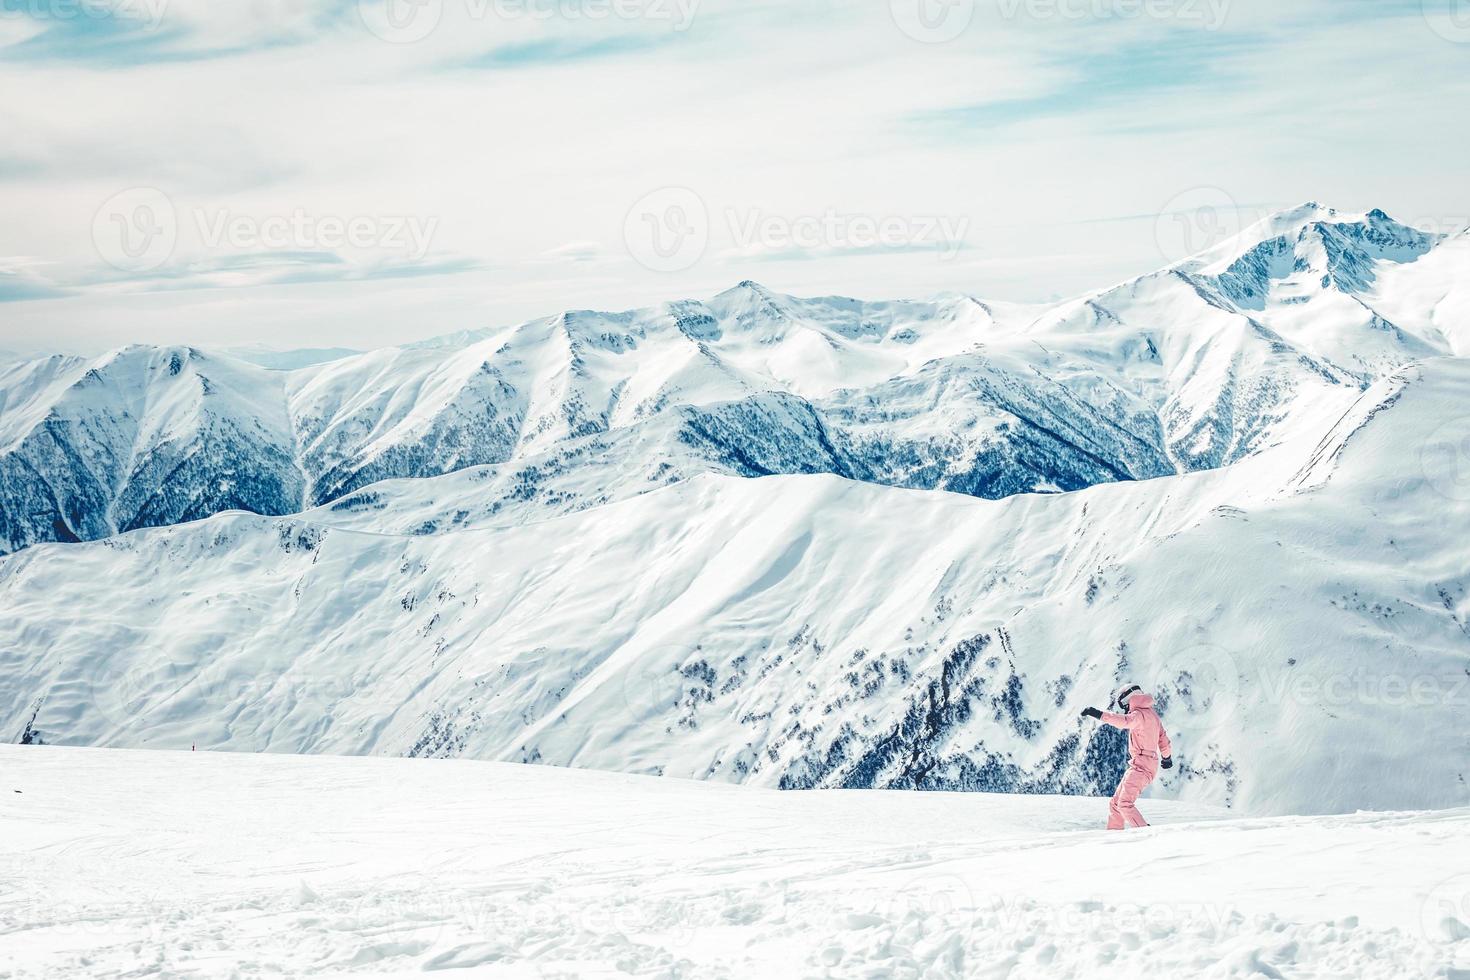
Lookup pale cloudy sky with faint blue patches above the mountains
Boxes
[0,0,1470,354]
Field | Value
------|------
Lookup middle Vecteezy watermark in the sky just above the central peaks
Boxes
[623,187,970,272]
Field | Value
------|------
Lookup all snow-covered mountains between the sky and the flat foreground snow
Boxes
[0,206,1470,813]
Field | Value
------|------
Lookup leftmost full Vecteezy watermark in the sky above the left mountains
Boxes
[91,187,440,273]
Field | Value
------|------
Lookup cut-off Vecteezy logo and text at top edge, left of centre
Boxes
[357,0,701,44]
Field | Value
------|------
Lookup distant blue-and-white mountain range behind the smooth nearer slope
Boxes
[0,204,1470,552]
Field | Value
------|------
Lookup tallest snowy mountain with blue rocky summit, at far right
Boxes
[1028,204,1470,470]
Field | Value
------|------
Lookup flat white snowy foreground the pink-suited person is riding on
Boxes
[0,745,1470,980]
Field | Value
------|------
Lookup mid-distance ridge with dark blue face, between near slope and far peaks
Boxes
[312,354,1173,533]
